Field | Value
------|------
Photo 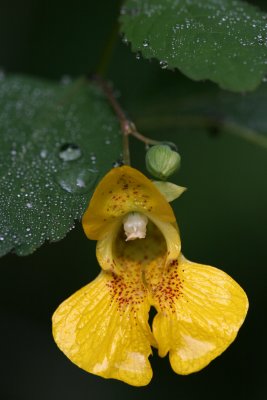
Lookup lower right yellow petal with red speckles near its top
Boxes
[149,256,248,374]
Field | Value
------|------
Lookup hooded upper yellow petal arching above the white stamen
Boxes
[82,166,175,240]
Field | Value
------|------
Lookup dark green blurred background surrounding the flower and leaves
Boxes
[0,0,267,400]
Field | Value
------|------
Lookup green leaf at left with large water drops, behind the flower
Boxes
[0,76,121,255]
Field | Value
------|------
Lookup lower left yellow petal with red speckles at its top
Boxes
[53,272,153,386]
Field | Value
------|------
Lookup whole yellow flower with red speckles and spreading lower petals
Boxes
[53,166,248,386]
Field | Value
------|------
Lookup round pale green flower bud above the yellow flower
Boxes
[146,144,181,180]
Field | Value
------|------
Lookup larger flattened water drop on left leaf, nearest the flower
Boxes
[56,166,98,193]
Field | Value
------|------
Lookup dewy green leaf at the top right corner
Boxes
[121,0,267,91]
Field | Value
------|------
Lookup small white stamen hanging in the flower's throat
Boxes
[123,212,148,242]
